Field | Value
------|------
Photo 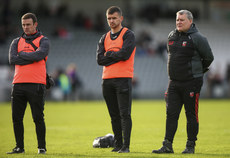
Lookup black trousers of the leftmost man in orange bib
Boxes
[11,83,46,149]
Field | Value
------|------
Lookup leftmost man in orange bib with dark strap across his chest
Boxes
[8,13,50,154]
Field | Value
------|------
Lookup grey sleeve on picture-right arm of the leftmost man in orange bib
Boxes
[19,37,50,62]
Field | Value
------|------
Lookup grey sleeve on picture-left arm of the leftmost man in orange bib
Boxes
[9,38,33,65]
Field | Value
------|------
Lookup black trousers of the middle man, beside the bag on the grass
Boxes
[102,78,132,147]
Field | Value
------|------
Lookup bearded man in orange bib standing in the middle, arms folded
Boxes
[97,6,136,153]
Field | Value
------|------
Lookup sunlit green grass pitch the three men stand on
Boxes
[0,99,230,158]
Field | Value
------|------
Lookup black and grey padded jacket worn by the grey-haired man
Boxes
[167,24,214,81]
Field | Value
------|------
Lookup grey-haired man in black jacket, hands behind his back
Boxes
[152,10,214,154]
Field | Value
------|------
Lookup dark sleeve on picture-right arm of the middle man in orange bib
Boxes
[106,30,136,61]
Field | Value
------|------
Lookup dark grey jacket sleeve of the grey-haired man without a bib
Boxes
[195,35,214,72]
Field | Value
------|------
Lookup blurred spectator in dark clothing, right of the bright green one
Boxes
[66,63,82,100]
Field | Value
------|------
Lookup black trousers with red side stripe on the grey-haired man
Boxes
[165,77,203,142]
